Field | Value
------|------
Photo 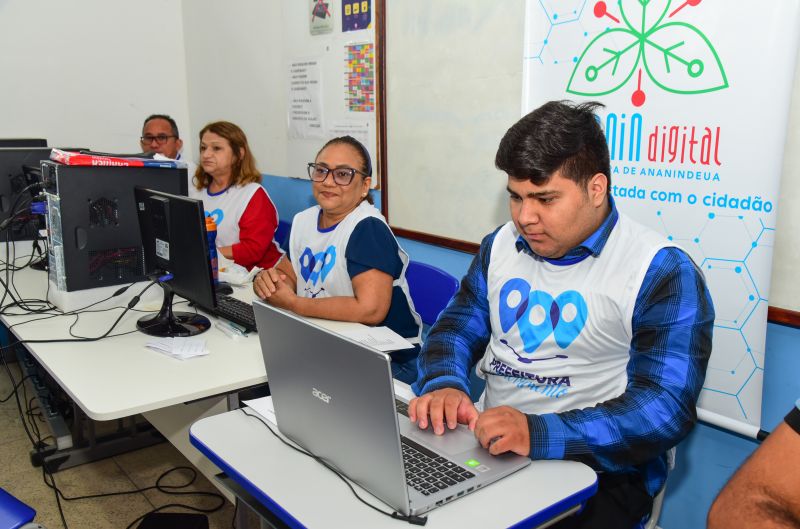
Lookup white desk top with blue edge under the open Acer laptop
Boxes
[190,410,597,529]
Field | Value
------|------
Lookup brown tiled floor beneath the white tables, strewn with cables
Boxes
[0,354,233,529]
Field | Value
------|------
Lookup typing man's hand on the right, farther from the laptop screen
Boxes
[475,406,531,456]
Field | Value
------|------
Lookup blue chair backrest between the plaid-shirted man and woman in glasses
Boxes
[406,261,458,325]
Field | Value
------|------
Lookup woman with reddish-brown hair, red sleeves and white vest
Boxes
[189,121,283,270]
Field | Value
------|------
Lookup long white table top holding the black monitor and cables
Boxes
[2,245,267,421]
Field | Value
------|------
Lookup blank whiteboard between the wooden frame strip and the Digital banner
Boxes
[386,0,525,242]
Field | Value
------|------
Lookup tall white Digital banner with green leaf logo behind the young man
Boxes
[522,0,800,432]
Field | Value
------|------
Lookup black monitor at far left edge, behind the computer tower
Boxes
[0,147,50,240]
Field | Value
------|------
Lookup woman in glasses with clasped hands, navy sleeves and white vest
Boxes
[253,136,421,384]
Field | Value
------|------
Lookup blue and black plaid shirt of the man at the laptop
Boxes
[413,201,714,495]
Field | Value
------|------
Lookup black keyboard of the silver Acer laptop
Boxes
[400,437,475,496]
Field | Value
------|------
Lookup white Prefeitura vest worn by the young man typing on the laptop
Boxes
[478,215,673,414]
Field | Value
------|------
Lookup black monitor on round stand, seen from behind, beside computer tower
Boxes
[134,187,217,337]
